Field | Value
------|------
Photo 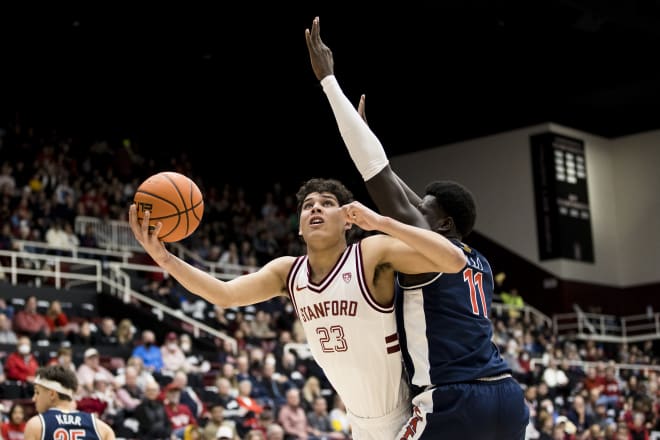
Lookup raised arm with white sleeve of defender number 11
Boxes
[305,17,429,229]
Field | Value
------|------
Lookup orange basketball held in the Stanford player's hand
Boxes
[133,171,204,243]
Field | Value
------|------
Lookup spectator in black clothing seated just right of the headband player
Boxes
[134,381,172,440]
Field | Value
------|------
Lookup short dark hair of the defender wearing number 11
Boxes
[424,180,477,237]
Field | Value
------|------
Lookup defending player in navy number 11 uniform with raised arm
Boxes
[305,17,529,440]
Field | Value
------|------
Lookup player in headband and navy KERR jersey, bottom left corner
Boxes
[25,365,115,440]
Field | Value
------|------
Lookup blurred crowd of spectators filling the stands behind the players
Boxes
[0,120,660,440]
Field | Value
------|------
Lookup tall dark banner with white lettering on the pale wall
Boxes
[530,133,594,263]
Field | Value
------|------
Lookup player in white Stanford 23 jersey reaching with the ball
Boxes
[129,179,466,440]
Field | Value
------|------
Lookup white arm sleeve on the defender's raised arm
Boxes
[321,75,389,181]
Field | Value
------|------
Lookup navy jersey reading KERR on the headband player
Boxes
[39,409,101,440]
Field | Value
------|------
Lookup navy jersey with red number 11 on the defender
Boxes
[396,240,511,387]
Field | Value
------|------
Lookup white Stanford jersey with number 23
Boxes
[287,243,408,418]
